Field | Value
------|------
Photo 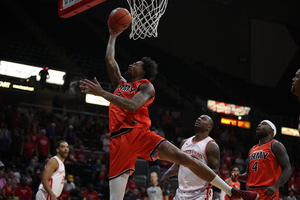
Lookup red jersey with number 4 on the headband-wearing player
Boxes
[246,139,282,187]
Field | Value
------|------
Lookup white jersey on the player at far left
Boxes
[39,156,66,197]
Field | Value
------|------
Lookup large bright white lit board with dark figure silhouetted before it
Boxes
[0,60,66,85]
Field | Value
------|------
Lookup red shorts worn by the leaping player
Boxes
[109,128,166,179]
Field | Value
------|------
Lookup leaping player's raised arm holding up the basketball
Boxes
[105,24,124,88]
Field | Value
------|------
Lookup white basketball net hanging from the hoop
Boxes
[127,0,168,40]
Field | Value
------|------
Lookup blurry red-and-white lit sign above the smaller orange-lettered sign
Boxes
[207,100,251,116]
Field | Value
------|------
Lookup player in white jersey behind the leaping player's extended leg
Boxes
[161,115,220,200]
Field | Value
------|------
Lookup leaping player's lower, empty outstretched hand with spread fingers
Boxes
[79,77,104,96]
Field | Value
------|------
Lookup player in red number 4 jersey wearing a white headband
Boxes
[233,120,291,200]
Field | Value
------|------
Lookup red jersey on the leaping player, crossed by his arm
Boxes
[109,79,154,133]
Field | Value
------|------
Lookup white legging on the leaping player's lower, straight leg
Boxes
[109,173,129,200]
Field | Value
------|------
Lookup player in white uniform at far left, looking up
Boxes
[36,140,69,200]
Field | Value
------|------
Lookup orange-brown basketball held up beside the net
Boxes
[108,8,132,31]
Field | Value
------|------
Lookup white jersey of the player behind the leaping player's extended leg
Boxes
[178,136,214,192]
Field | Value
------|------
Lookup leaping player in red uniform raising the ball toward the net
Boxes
[80,23,258,200]
